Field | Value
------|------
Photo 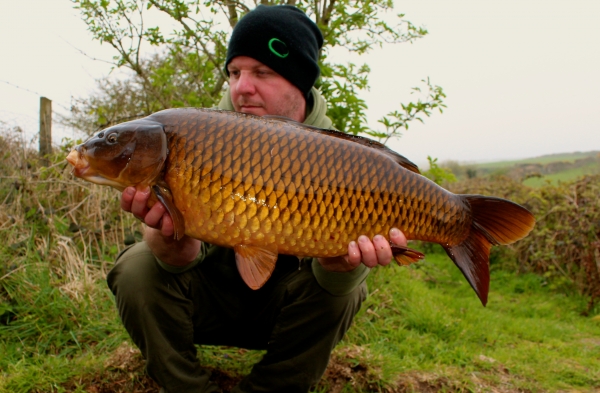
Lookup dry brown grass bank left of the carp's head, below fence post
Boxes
[0,131,142,290]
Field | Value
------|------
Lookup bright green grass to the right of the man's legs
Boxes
[338,250,600,391]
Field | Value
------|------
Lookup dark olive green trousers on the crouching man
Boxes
[107,242,366,393]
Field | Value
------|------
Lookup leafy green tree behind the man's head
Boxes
[67,0,445,142]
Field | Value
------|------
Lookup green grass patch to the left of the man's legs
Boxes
[0,259,126,392]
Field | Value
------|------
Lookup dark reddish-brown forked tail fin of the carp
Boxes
[444,195,535,306]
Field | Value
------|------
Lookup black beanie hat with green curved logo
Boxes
[225,5,323,97]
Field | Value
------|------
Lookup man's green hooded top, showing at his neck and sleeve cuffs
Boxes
[157,87,369,295]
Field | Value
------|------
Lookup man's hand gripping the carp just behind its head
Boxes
[121,187,202,266]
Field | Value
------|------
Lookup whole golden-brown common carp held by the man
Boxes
[67,108,535,305]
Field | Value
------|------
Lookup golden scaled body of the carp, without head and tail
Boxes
[156,112,470,257]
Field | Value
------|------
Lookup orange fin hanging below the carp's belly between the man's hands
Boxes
[233,244,277,289]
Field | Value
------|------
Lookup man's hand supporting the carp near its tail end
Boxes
[318,228,407,272]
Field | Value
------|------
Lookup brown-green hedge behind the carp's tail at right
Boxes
[451,175,600,312]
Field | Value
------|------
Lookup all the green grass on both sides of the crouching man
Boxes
[0,247,600,393]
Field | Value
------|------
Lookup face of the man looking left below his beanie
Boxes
[227,56,306,122]
